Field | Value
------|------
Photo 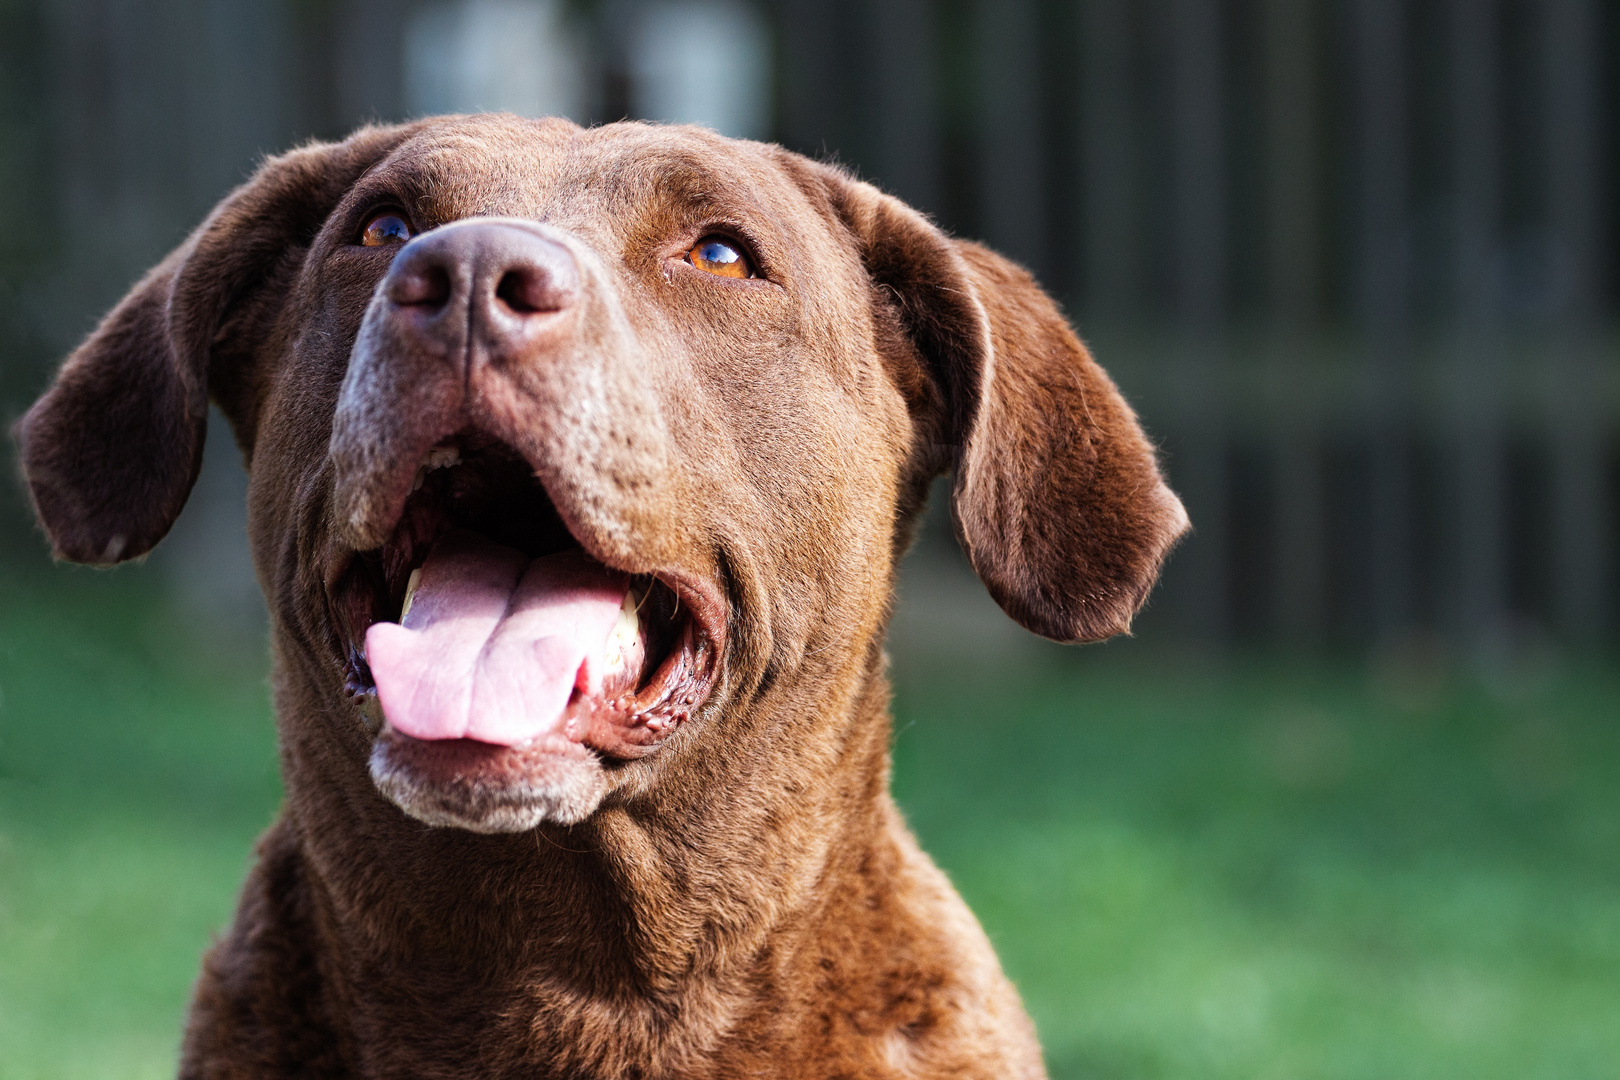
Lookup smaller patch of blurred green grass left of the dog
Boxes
[0,568,280,1080]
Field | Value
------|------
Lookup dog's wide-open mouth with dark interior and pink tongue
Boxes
[327,431,719,764]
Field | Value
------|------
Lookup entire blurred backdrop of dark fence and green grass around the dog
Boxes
[0,0,1620,1080]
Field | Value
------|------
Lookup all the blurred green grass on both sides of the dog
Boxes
[0,568,1620,1080]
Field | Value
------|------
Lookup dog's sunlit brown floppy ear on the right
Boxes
[815,165,1187,641]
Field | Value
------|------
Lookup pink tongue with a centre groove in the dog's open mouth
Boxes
[366,533,630,746]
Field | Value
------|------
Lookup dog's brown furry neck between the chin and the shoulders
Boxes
[262,649,910,1074]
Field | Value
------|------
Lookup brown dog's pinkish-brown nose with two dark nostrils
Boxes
[382,219,580,363]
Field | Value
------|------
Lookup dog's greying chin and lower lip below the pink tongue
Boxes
[371,725,609,832]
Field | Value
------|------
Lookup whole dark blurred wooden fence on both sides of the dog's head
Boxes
[0,0,1620,644]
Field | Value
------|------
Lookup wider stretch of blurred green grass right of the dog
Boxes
[896,649,1620,1080]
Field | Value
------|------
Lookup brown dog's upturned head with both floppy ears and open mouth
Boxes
[16,117,1186,832]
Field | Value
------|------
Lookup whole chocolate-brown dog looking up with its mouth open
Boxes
[18,117,1186,1078]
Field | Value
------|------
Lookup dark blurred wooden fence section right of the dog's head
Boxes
[776,0,1620,644]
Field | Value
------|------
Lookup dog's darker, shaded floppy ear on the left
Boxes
[13,128,410,565]
